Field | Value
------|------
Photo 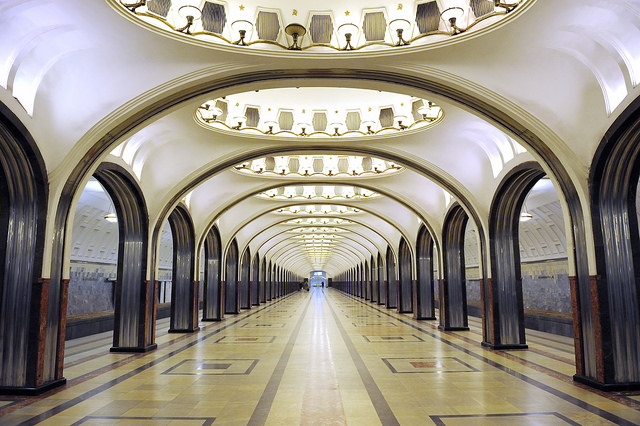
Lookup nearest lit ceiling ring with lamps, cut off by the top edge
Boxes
[111,0,526,52]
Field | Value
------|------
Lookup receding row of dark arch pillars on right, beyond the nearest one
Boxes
[336,162,564,349]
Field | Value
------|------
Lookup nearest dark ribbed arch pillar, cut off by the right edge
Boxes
[588,99,640,389]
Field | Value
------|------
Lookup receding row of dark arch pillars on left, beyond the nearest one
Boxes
[70,172,297,352]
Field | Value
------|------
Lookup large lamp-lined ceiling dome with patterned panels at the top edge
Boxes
[111,0,528,52]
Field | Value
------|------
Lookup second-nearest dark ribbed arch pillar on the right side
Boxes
[483,162,545,349]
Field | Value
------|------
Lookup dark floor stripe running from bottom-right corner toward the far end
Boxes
[338,290,635,426]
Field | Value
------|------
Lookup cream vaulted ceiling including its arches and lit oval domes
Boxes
[0,0,640,276]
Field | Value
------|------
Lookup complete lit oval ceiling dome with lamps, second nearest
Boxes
[195,87,444,138]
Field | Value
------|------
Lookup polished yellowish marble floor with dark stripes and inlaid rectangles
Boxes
[0,288,640,426]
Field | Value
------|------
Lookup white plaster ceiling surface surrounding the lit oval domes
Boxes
[0,0,640,276]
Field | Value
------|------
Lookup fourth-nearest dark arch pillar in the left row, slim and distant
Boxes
[202,226,224,321]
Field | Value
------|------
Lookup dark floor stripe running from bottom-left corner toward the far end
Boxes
[19,293,296,426]
